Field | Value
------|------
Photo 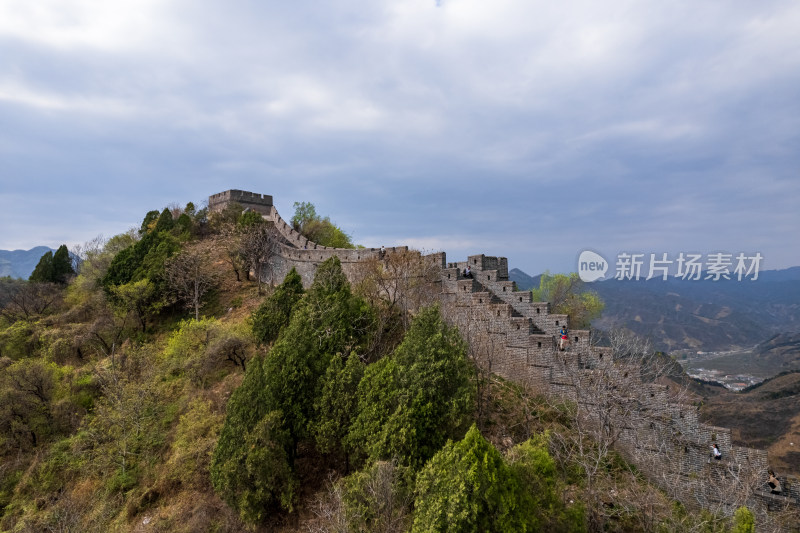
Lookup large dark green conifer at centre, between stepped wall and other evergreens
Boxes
[348,306,475,469]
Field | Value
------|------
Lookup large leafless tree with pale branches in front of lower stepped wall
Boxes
[553,330,686,529]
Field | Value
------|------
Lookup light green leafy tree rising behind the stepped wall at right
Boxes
[531,272,605,329]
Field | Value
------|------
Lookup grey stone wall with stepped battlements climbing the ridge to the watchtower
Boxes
[209,190,800,513]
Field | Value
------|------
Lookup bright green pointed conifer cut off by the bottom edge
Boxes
[411,425,539,533]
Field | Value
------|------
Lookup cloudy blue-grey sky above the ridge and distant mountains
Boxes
[0,0,800,274]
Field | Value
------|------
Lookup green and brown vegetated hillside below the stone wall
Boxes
[0,204,788,532]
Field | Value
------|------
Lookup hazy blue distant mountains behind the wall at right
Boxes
[509,267,800,352]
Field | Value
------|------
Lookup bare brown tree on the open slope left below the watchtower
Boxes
[166,247,217,320]
